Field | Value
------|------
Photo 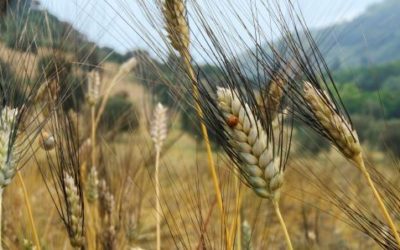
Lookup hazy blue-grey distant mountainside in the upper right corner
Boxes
[315,0,400,68]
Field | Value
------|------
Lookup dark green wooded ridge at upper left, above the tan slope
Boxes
[0,0,126,63]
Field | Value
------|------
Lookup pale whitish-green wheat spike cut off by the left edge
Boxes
[0,107,18,189]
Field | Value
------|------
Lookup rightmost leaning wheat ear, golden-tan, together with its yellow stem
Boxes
[304,82,400,247]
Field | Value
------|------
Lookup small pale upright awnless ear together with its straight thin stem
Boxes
[150,103,167,250]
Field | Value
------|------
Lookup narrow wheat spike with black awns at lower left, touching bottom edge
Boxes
[64,173,84,248]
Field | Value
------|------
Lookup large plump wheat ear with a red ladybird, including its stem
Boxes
[217,88,293,249]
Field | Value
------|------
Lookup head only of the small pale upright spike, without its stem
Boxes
[150,103,167,149]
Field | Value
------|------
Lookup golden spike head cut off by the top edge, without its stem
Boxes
[164,0,190,51]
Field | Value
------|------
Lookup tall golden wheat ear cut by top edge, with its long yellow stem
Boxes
[163,0,231,246]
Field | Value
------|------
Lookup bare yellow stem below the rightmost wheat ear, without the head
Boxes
[354,154,400,247]
